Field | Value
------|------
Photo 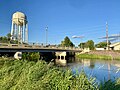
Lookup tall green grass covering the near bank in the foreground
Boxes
[0,60,97,90]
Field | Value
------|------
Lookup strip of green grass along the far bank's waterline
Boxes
[76,54,120,60]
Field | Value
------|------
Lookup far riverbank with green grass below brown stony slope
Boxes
[76,51,120,60]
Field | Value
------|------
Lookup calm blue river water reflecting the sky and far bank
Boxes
[67,59,120,82]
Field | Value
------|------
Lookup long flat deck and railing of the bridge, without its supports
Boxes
[0,44,82,52]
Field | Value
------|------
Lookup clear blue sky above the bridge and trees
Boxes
[0,0,120,45]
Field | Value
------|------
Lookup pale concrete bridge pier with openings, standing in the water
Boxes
[55,52,67,66]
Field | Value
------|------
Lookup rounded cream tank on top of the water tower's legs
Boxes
[12,12,27,26]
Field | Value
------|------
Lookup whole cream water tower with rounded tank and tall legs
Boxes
[11,12,28,43]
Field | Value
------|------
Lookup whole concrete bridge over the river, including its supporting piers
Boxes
[0,43,82,65]
